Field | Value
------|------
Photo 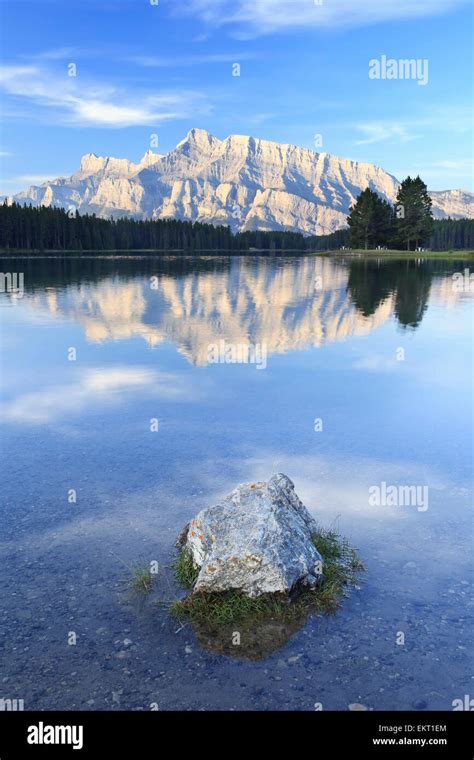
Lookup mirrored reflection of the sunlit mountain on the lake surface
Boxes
[2,256,463,366]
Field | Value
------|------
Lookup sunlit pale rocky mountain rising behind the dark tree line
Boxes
[8,129,474,235]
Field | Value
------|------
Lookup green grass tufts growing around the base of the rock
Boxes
[170,529,364,625]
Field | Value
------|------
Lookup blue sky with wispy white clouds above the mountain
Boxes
[0,0,474,195]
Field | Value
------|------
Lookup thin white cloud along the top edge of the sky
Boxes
[179,0,468,34]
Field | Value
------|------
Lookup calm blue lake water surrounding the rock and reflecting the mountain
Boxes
[0,257,474,710]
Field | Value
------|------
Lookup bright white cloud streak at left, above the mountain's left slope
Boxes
[0,65,206,127]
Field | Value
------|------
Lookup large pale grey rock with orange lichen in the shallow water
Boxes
[181,474,322,597]
